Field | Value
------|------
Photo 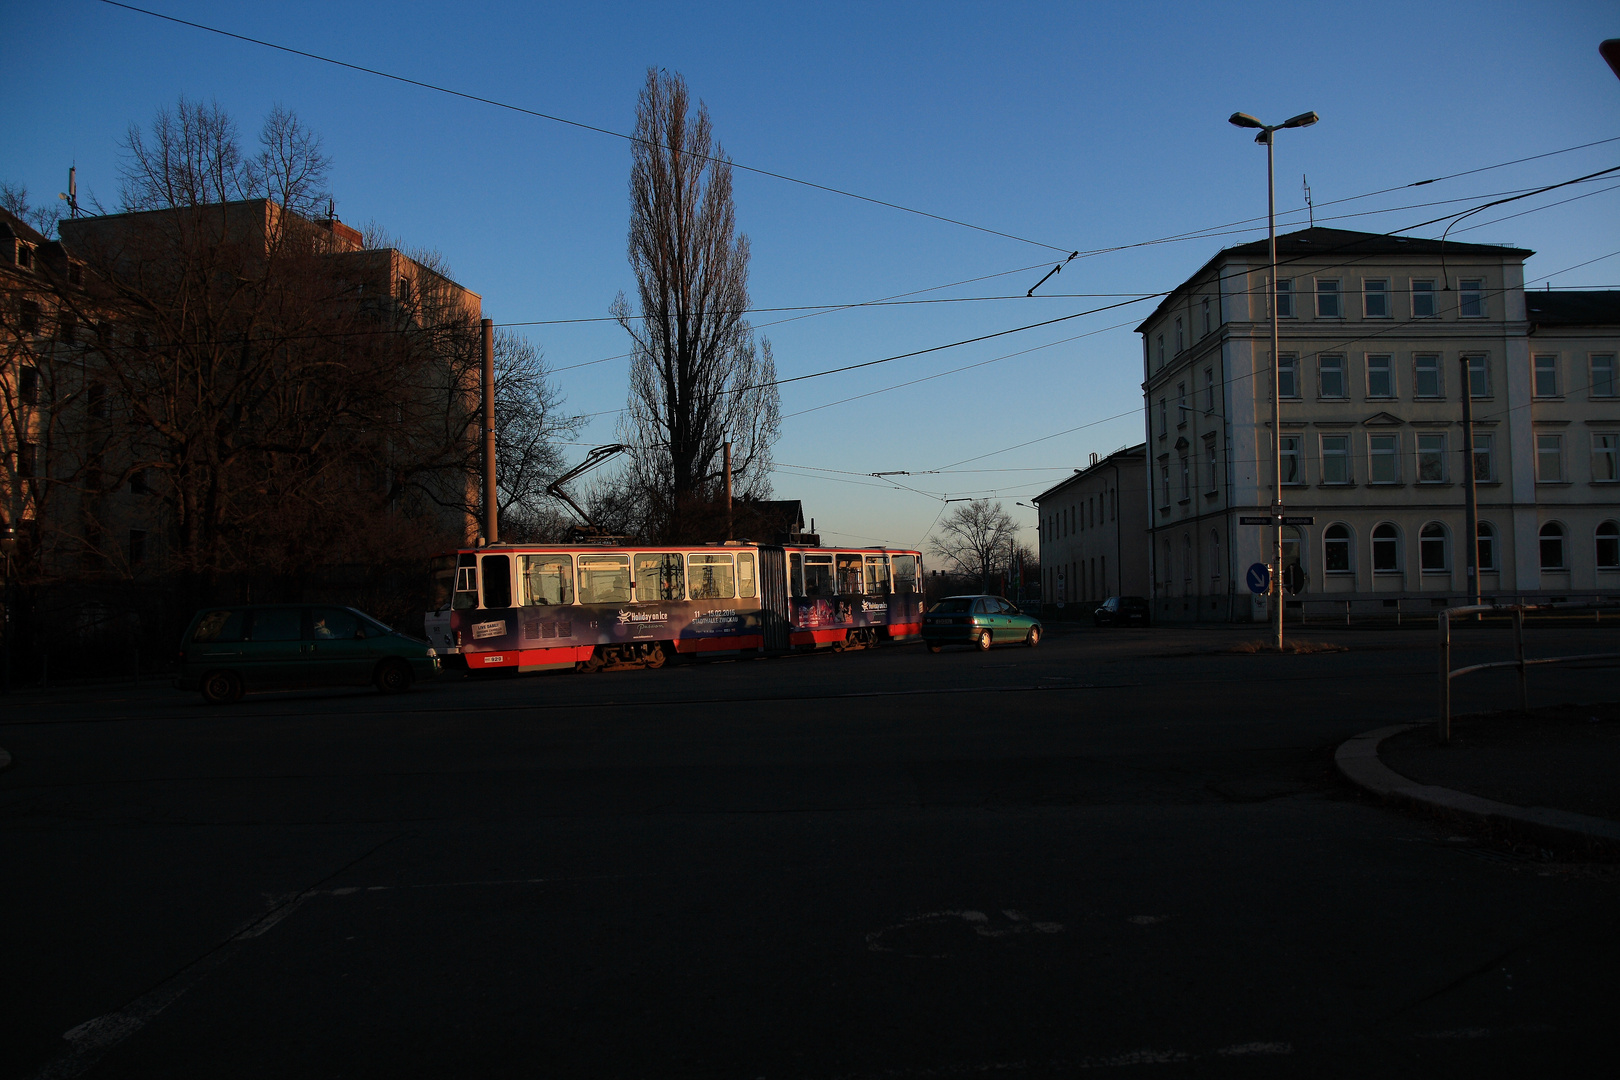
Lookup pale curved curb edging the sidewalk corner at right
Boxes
[1333,724,1620,847]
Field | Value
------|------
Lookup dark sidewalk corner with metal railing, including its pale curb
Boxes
[1337,704,1620,850]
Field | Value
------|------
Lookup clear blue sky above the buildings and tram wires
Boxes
[9,0,1620,546]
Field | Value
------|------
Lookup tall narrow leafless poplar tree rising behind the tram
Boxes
[612,70,781,539]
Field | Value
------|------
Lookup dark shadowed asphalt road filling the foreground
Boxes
[0,627,1620,1080]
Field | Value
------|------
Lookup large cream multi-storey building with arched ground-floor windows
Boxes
[1137,228,1620,620]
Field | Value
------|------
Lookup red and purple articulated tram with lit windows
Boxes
[424,541,923,672]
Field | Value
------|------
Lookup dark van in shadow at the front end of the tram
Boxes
[175,604,439,704]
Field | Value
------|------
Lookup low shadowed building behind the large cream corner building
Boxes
[1035,444,1150,612]
